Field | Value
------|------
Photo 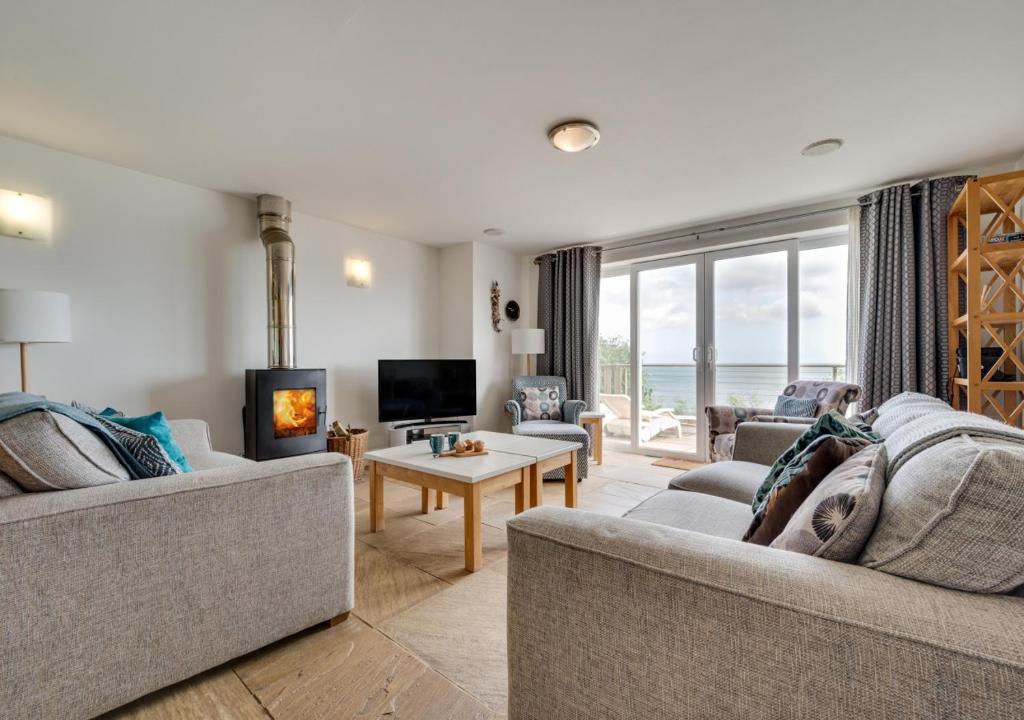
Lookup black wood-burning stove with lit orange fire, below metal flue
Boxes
[243,368,327,460]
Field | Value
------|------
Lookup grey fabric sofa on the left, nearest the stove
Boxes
[0,420,354,720]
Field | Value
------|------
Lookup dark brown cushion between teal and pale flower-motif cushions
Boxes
[743,435,871,545]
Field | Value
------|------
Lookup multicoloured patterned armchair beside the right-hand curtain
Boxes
[705,380,860,463]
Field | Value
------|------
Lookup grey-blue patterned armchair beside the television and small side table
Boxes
[505,375,590,480]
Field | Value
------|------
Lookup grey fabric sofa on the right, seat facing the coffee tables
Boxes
[508,407,1024,720]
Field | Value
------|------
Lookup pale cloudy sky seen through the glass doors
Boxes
[600,245,847,365]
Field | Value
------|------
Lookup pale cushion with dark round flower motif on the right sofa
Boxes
[771,444,886,562]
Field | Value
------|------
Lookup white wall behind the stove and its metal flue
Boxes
[0,137,440,452]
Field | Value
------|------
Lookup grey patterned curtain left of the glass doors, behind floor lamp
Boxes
[537,246,601,409]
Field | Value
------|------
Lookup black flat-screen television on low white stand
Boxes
[377,359,476,423]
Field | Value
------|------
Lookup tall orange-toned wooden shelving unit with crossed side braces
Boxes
[946,171,1024,427]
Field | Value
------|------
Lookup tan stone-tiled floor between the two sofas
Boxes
[104,450,679,720]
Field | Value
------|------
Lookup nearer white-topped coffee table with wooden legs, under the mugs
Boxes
[367,440,537,573]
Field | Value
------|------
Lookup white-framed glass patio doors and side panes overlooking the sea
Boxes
[600,230,847,460]
